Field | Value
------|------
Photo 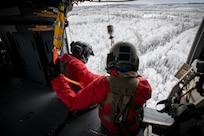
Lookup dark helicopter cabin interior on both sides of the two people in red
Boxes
[0,0,204,136]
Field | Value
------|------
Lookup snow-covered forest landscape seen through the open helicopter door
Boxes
[64,3,204,108]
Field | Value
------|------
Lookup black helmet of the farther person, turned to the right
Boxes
[71,41,94,63]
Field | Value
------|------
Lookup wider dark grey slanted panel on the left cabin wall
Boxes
[13,32,46,84]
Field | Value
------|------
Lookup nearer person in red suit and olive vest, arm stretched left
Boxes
[48,42,152,136]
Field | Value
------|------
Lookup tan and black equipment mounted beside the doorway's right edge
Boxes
[157,60,204,117]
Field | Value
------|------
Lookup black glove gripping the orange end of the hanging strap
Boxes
[48,58,61,80]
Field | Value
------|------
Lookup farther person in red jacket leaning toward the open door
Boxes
[51,41,99,93]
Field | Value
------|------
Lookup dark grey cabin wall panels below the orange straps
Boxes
[1,28,53,84]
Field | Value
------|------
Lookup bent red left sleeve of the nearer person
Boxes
[51,75,109,111]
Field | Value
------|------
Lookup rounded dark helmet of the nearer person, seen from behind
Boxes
[106,42,139,72]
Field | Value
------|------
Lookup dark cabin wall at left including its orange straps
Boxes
[0,3,56,85]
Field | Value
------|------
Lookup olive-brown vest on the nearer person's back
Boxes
[99,75,143,127]
